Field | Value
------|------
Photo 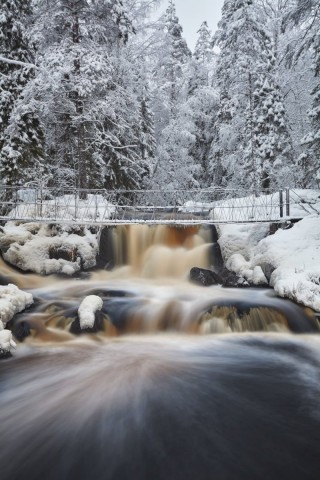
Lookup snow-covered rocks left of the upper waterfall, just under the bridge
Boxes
[0,222,98,275]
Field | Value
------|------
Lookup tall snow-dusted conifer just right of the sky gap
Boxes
[212,0,292,193]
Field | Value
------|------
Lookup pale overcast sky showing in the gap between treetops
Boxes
[168,0,224,51]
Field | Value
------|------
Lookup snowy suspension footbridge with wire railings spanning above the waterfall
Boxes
[0,187,319,226]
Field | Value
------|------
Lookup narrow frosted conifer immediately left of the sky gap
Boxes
[152,0,192,188]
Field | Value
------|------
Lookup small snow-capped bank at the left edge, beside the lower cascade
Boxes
[0,284,33,355]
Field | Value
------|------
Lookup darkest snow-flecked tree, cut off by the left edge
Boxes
[0,0,44,185]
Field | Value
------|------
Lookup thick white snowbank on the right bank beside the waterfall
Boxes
[219,215,320,311]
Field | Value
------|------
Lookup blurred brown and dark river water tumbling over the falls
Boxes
[0,226,320,480]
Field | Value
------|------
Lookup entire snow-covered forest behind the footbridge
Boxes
[0,0,320,193]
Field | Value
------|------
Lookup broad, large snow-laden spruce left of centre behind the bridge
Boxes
[30,0,148,189]
